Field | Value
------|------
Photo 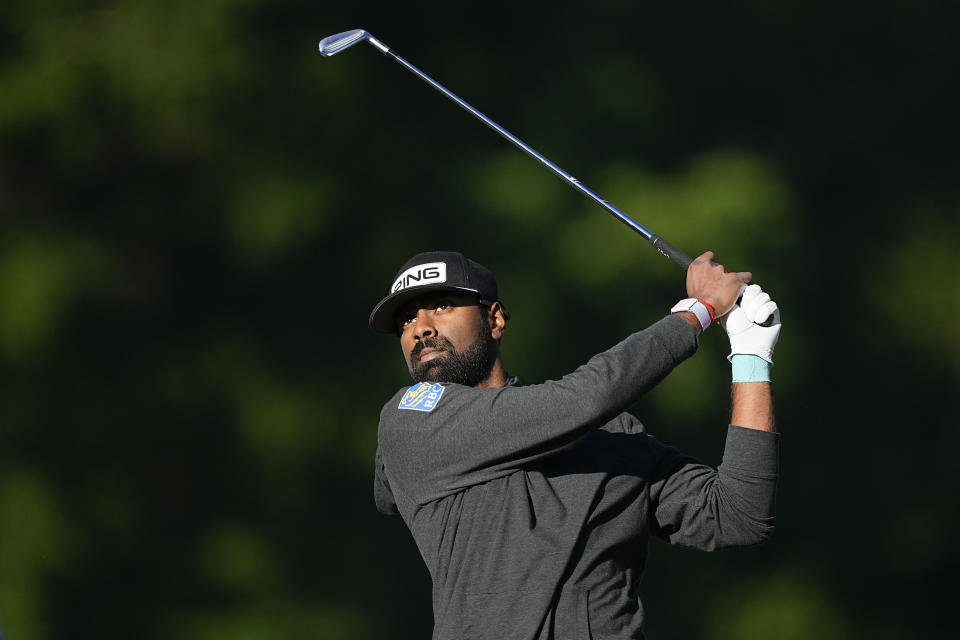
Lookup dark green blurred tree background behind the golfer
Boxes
[0,0,960,640]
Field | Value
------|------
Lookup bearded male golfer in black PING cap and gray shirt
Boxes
[370,251,780,640]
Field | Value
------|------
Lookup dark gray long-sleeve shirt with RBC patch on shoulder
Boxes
[374,316,778,640]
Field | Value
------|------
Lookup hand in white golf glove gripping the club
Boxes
[718,284,780,364]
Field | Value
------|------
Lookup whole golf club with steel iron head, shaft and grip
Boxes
[320,29,693,271]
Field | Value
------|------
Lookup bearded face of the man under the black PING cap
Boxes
[397,291,498,387]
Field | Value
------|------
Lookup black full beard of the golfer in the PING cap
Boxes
[410,314,497,387]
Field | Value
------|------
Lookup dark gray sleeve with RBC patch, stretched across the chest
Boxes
[380,315,697,504]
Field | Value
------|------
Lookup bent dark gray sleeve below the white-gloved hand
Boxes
[650,425,780,551]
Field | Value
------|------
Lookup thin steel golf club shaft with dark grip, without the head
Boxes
[367,36,693,270]
